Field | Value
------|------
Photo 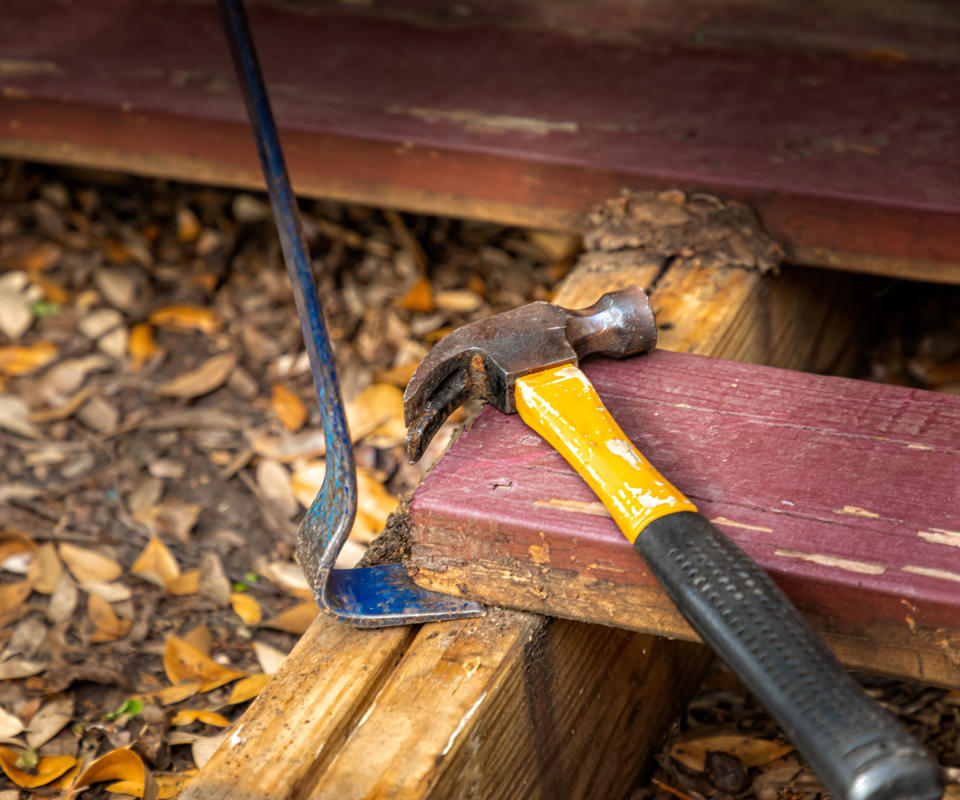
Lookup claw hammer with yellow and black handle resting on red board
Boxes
[403,287,944,800]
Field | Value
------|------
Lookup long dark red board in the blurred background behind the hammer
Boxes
[0,0,960,280]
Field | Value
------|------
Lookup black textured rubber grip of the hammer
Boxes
[635,511,944,800]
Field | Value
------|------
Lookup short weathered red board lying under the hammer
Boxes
[410,351,960,667]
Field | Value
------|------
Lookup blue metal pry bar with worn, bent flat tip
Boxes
[219,0,484,628]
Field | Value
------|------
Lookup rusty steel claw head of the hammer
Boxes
[403,286,657,461]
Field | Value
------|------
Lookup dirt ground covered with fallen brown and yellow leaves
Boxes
[0,162,960,800]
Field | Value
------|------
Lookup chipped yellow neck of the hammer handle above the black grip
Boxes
[515,364,697,544]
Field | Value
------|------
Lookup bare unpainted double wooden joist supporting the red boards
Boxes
[185,264,854,800]
